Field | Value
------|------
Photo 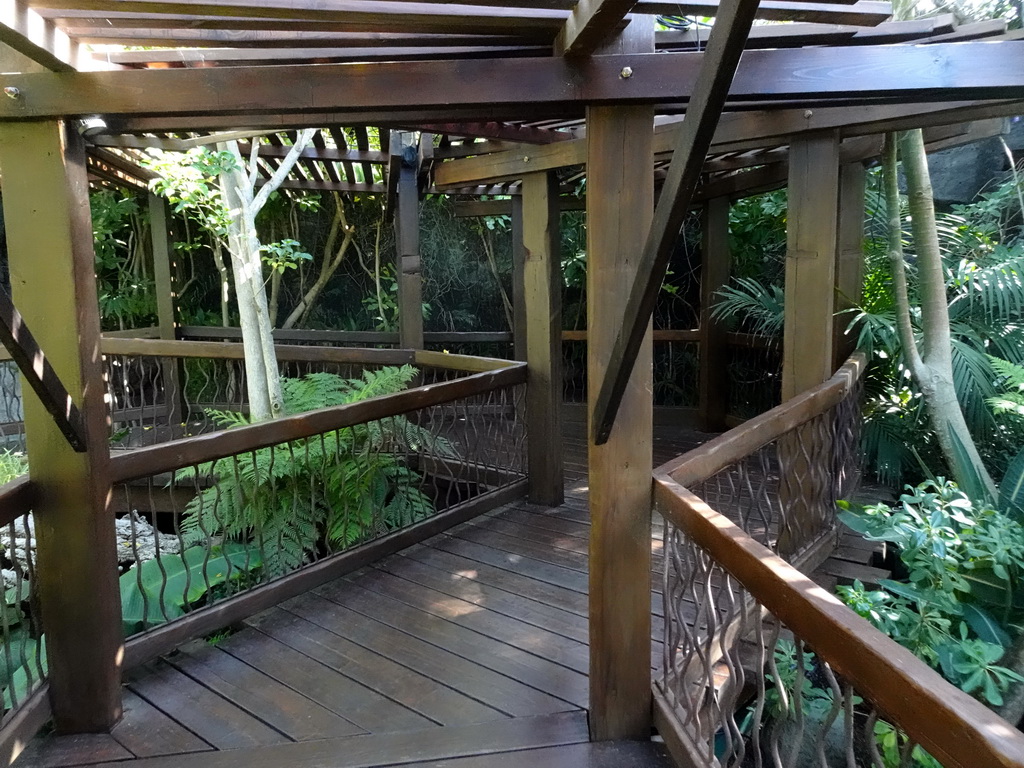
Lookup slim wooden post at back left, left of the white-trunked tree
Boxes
[150,193,187,424]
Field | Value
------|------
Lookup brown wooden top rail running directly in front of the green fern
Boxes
[111,362,526,482]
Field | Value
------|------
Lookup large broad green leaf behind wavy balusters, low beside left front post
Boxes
[121,542,262,637]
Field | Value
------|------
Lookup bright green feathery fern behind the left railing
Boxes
[177,366,456,578]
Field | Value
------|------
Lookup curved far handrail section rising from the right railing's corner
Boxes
[654,352,867,485]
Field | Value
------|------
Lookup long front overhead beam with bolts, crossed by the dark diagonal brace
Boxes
[6,40,1024,122]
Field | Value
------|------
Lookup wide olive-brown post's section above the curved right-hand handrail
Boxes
[782,131,839,401]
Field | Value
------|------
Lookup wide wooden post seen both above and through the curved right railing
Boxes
[777,131,840,556]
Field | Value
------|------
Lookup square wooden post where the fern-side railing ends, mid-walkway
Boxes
[522,173,565,507]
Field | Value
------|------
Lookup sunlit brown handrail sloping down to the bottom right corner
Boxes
[654,472,1024,768]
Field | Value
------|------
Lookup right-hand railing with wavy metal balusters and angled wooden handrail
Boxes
[653,357,1024,768]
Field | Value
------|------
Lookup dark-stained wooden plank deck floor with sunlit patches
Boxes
[15,425,702,768]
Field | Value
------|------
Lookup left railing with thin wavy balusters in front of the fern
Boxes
[104,342,526,667]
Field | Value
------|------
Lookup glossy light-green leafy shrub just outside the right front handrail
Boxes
[838,478,1024,706]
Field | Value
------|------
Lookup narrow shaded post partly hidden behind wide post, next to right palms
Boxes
[833,163,866,371]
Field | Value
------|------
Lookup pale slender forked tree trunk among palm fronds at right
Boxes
[886,130,995,498]
